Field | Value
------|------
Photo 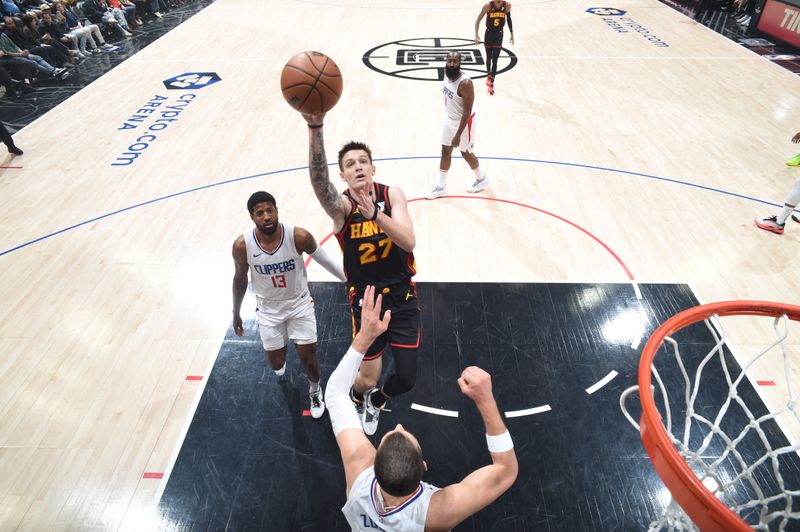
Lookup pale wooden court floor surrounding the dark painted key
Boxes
[0,0,800,530]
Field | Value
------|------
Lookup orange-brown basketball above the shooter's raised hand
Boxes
[281,52,342,114]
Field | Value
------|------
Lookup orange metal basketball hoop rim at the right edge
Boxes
[639,300,800,532]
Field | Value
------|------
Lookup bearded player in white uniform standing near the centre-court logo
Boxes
[425,52,489,199]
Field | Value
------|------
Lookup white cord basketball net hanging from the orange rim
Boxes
[620,315,800,530]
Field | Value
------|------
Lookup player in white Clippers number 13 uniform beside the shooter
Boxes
[233,191,344,419]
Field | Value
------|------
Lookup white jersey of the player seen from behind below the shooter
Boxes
[342,467,439,532]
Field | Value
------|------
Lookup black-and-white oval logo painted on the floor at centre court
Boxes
[364,37,517,81]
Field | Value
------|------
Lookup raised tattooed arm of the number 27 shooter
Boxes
[303,114,349,231]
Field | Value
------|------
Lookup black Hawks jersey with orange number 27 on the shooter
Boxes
[336,183,416,290]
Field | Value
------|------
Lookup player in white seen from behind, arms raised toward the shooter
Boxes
[325,286,518,532]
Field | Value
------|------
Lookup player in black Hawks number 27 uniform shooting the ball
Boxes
[303,113,419,435]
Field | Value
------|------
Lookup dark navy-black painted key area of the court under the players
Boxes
[160,283,797,531]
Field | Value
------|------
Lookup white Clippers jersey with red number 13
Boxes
[244,224,308,307]
